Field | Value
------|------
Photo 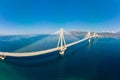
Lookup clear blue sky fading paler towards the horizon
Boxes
[0,0,120,34]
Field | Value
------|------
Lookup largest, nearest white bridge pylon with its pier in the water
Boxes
[57,28,67,55]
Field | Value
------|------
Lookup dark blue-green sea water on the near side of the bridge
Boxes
[0,35,120,80]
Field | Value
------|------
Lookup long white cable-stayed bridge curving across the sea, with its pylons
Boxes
[0,28,97,60]
